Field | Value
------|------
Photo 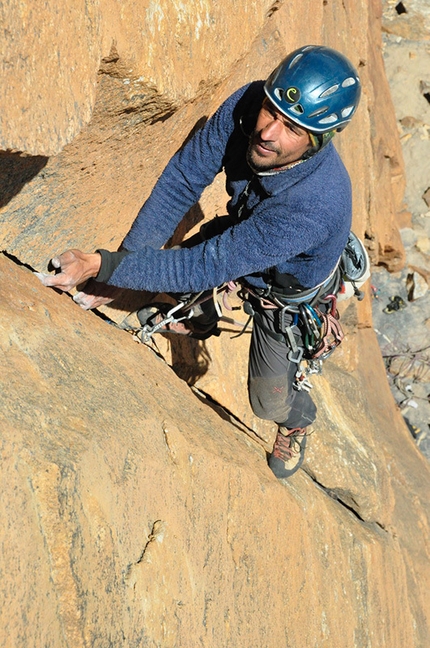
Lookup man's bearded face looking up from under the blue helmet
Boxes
[247,97,311,172]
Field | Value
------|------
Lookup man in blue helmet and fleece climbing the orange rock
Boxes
[39,45,360,479]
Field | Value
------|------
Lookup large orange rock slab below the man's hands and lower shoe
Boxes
[0,257,430,648]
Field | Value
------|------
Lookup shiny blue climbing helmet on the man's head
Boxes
[264,45,361,135]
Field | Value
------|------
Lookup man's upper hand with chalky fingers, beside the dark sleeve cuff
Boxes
[34,250,102,292]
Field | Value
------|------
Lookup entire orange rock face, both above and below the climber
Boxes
[0,0,430,648]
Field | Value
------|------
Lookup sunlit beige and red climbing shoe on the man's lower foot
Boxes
[269,426,308,479]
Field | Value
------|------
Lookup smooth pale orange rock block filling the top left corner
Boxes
[0,0,101,155]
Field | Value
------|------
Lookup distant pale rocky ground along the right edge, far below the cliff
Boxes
[372,0,430,459]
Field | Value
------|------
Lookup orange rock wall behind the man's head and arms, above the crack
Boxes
[0,0,404,269]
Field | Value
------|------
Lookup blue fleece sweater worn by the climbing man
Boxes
[102,82,351,292]
